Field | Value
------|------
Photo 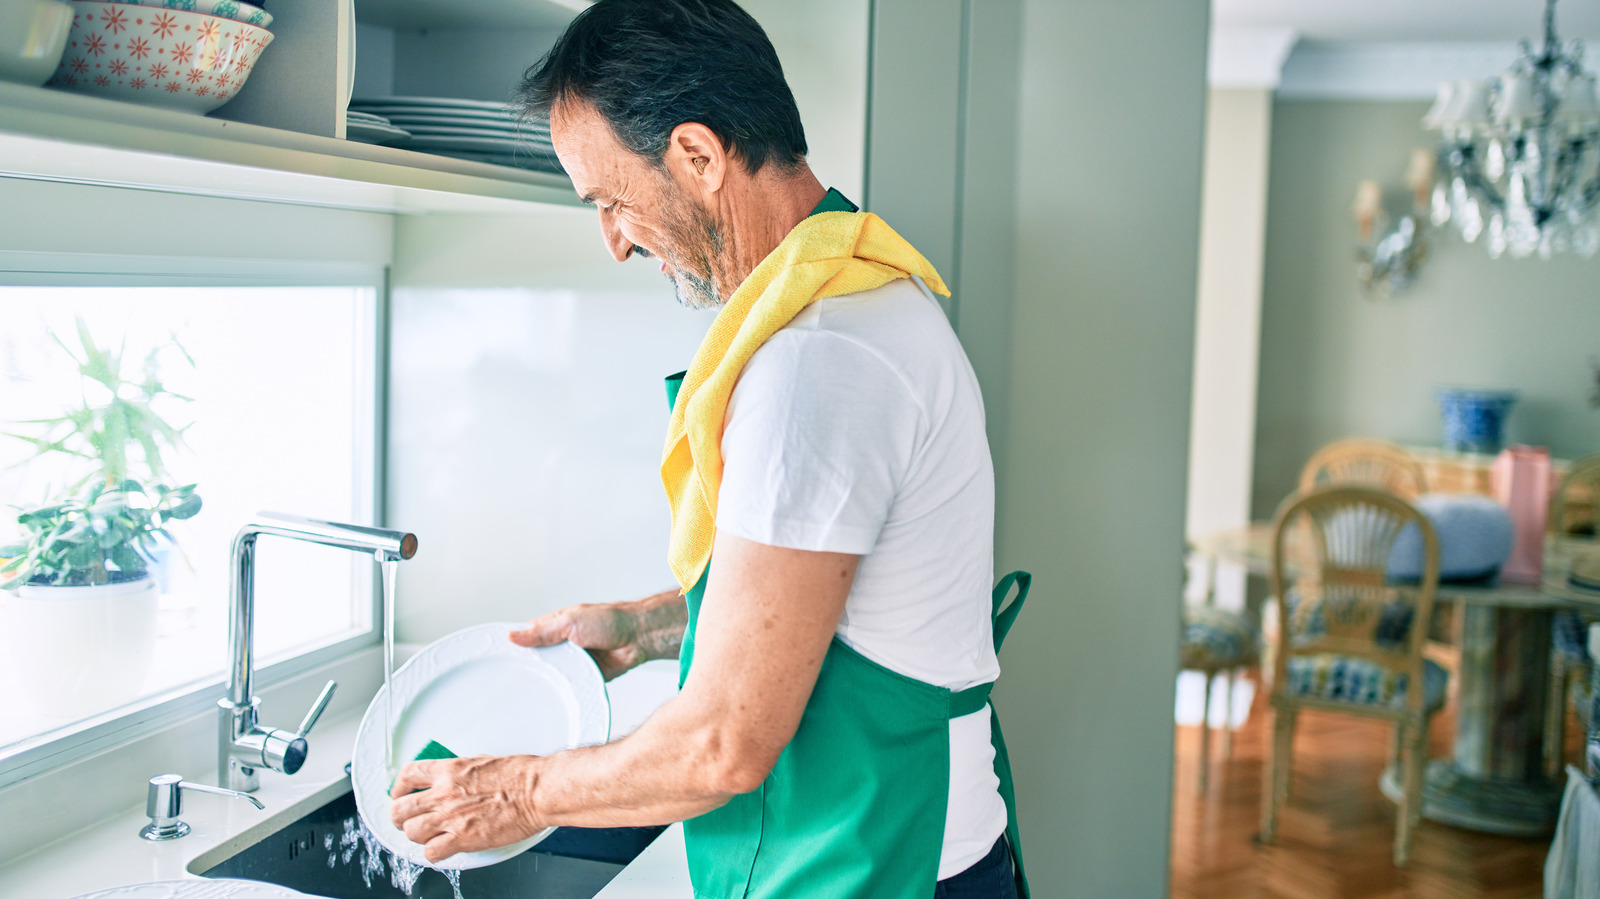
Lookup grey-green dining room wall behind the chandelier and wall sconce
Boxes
[1253,99,1600,518]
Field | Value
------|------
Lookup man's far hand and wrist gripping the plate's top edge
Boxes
[510,590,688,680]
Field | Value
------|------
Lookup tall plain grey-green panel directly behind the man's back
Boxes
[867,0,1208,899]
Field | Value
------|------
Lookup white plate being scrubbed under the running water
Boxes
[350,624,611,869]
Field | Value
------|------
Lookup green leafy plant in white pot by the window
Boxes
[0,320,202,717]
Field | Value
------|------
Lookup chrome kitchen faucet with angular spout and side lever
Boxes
[216,512,416,793]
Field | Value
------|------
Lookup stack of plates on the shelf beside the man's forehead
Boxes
[350,96,562,173]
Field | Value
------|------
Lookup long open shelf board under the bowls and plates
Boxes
[0,82,578,213]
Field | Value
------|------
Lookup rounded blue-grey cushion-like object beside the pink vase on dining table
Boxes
[1389,493,1515,581]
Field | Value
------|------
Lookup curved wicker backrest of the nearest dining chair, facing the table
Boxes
[1272,486,1438,715]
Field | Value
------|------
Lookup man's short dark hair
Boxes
[514,0,806,174]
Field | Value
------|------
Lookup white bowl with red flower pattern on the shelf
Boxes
[50,0,272,115]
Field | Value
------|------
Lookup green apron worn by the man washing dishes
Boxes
[667,374,1032,899]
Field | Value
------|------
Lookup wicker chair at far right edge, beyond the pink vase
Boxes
[1544,454,1600,777]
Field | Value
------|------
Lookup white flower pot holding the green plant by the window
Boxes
[0,577,160,718]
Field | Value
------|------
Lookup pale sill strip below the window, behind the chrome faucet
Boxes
[0,646,382,865]
